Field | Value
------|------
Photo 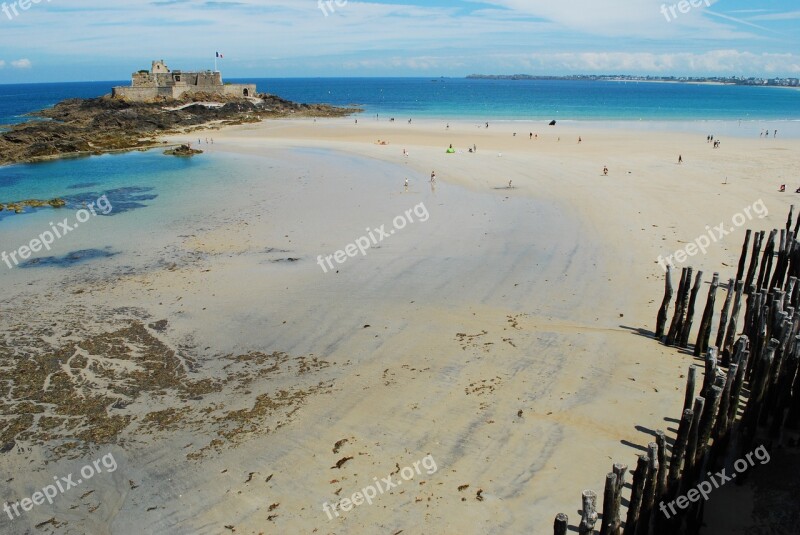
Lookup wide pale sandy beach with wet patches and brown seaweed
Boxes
[0,116,800,535]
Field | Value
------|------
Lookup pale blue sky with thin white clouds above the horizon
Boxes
[0,0,800,83]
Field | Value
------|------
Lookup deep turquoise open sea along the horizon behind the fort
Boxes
[0,78,800,124]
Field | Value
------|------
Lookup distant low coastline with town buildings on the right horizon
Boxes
[467,74,800,87]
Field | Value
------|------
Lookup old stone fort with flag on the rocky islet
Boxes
[112,59,256,102]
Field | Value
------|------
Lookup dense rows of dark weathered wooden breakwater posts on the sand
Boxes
[554,207,800,535]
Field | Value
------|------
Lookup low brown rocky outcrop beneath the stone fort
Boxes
[0,94,361,165]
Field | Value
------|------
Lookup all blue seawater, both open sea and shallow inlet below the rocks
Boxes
[0,78,800,270]
